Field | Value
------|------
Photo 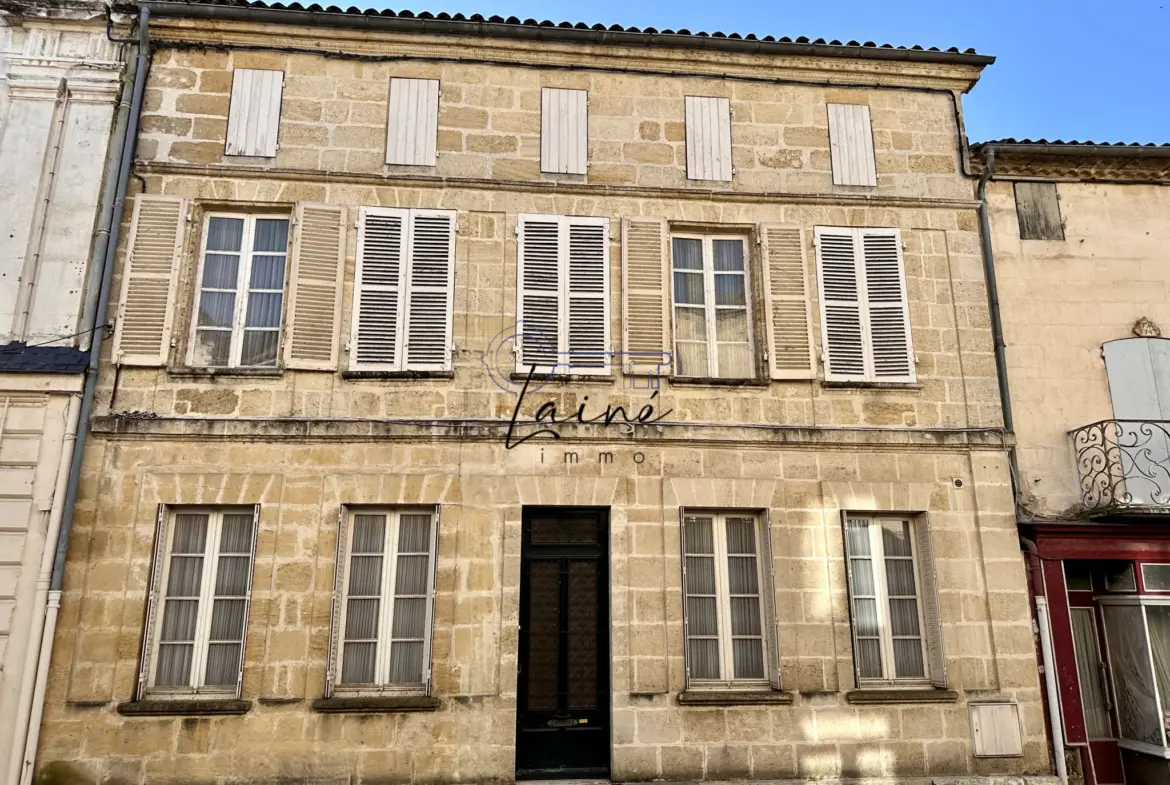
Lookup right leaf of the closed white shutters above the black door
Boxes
[562,216,611,373]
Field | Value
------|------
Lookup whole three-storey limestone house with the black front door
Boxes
[37,1,1052,784]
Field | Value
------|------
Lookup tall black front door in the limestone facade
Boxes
[516,508,610,778]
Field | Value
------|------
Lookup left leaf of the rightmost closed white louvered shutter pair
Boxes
[815,227,868,381]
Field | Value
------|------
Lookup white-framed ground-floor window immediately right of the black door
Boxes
[682,510,775,687]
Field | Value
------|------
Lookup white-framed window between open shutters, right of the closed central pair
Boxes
[670,234,756,379]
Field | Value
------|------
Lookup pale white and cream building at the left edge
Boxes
[0,0,123,781]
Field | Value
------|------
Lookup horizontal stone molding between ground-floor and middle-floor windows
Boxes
[91,413,1014,452]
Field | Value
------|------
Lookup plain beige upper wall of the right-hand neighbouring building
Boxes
[989,183,1170,515]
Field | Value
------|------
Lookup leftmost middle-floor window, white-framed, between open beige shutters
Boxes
[191,213,289,367]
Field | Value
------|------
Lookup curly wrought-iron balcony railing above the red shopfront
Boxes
[1069,420,1170,515]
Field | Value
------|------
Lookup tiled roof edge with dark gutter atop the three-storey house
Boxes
[142,0,996,67]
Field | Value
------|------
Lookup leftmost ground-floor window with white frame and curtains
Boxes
[143,508,257,696]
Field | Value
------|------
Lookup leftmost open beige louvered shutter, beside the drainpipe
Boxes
[113,194,187,366]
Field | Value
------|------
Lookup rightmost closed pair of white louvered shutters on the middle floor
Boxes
[815,227,915,383]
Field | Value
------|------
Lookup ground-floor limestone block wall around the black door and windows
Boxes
[32,435,1048,784]
